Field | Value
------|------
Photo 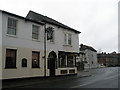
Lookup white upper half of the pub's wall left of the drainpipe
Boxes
[3,15,44,49]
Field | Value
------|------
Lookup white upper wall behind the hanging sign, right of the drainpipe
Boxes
[46,24,79,52]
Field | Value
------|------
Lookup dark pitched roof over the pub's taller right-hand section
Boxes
[26,10,81,33]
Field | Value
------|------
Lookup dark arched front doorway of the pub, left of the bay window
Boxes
[48,51,57,77]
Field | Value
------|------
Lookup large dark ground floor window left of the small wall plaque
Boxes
[5,49,17,68]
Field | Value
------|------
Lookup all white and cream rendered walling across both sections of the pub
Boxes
[2,14,79,79]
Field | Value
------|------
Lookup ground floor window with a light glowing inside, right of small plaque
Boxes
[32,51,40,68]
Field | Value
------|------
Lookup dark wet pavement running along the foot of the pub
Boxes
[2,70,91,89]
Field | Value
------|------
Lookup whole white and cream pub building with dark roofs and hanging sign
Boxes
[0,10,80,79]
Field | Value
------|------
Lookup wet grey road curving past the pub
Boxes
[11,67,120,88]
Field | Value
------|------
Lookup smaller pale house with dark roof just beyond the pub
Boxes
[80,44,98,68]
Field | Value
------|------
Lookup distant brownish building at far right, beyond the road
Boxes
[97,52,120,67]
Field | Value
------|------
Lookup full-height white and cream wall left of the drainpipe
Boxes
[2,14,44,79]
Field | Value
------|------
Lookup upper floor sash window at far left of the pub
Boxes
[7,18,17,35]
